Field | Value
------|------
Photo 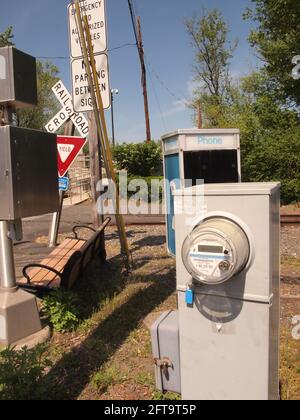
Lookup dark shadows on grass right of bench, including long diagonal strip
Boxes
[42,251,175,400]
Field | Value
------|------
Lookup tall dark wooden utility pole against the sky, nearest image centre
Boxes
[128,0,152,143]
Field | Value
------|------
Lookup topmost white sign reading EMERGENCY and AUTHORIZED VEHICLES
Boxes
[68,0,107,58]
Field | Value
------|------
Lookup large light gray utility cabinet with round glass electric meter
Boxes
[174,183,280,400]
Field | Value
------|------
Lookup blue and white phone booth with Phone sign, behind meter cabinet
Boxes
[162,129,241,255]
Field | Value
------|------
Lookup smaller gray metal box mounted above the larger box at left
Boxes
[0,47,37,108]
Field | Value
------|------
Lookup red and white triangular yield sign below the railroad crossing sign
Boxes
[57,136,86,177]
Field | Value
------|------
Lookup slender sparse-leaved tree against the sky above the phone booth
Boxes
[185,9,237,126]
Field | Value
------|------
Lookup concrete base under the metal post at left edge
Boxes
[0,288,43,347]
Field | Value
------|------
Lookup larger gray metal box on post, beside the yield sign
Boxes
[0,126,59,220]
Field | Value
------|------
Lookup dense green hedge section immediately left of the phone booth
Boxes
[113,141,162,177]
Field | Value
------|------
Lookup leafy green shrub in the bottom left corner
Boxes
[0,346,52,401]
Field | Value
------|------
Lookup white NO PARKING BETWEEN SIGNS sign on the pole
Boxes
[71,54,111,112]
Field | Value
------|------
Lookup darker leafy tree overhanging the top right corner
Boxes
[245,0,300,107]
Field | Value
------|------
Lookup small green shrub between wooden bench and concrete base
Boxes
[42,289,79,332]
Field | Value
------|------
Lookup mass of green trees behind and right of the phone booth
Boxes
[188,5,300,203]
